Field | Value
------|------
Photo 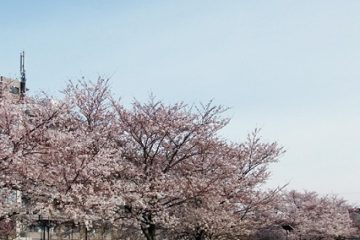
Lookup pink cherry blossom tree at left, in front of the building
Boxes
[0,79,121,236]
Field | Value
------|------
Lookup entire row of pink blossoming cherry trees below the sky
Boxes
[0,79,351,240]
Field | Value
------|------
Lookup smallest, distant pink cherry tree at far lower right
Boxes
[268,191,355,239]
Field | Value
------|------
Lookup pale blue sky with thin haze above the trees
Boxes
[0,0,360,205]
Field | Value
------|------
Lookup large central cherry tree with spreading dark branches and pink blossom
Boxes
[109,99,282,240]
